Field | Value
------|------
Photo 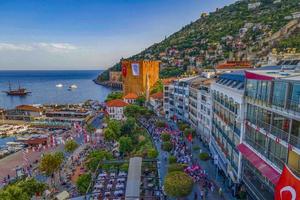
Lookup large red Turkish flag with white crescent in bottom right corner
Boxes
[275,166,300,200]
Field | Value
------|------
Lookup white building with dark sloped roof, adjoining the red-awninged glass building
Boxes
[209,71,245,191]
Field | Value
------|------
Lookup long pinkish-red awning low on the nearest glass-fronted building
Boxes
[237,144,280,185]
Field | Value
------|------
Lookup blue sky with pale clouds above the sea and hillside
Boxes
[0,0,235,70]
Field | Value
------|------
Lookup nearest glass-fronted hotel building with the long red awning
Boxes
[238,66,300,200]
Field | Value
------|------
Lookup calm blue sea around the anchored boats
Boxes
[0,70,111,108]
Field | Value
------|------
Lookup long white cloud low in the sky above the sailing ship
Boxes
[0,42,78,53]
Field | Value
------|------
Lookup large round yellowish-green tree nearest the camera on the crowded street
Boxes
[164,171,193,198]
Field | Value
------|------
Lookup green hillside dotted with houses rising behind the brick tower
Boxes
[98,0,300,80]
